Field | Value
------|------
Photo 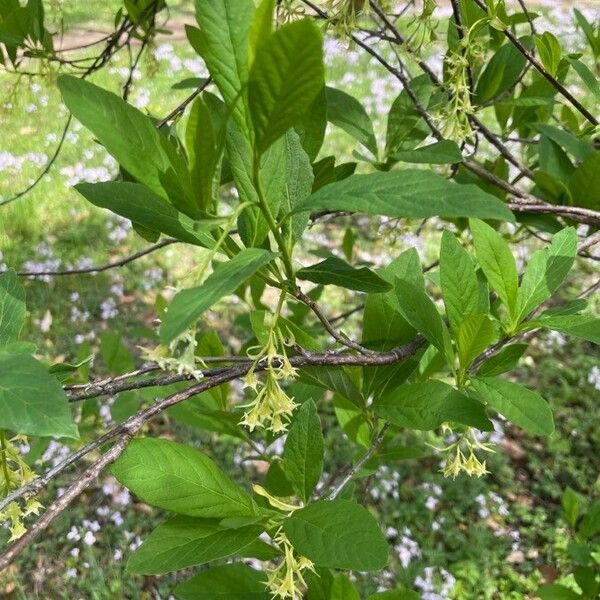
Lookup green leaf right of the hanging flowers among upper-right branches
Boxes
[474,39,527,104]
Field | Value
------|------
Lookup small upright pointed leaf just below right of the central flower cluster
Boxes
[282,400,324,502]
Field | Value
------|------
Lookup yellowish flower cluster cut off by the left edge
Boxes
[0,431,42,542]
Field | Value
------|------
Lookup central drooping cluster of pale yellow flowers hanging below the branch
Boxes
[241,323,297,433]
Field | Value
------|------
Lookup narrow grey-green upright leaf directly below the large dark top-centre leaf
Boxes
[281,130,314,242]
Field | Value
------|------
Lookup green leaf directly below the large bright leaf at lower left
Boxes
[127,515,262,575]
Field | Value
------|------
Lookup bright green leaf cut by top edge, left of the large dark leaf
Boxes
[193,0,254,139]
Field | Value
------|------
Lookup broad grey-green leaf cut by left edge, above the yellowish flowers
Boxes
[0,352,79,438]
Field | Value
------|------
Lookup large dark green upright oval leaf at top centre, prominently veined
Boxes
[248,19,325,154]
